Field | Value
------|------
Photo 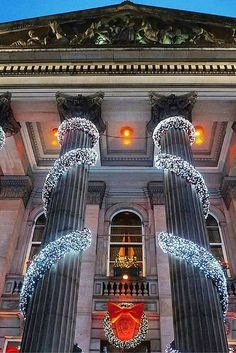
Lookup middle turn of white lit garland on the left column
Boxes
[42,148,97,215]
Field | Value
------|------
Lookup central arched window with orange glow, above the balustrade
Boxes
[108,210,144,277]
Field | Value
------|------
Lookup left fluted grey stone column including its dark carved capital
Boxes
[22,93,104,352]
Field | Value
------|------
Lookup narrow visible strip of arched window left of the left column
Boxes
[26,213,46,268]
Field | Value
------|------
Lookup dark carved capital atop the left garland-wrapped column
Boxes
[56,92,106,133]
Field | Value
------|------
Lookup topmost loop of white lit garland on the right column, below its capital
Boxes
[153,116,195,149]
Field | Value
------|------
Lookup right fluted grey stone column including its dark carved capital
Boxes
[148,94,227,353]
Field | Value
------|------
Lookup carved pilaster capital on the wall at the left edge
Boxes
[0,176,32,205]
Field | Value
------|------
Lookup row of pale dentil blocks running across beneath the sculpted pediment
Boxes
[0,62,236,77]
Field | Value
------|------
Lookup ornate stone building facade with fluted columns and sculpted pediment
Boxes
[0,2,236,353]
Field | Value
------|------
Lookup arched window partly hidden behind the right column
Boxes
[206,214,227,263]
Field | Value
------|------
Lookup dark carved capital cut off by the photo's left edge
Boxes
[0,92,21,137]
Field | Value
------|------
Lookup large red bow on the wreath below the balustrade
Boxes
[108,303,144,324]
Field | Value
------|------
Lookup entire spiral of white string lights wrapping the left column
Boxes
[19,118,99,318]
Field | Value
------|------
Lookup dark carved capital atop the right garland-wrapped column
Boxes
[147,92,197,133]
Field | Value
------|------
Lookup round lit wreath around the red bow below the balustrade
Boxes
[103,303,148,349]
